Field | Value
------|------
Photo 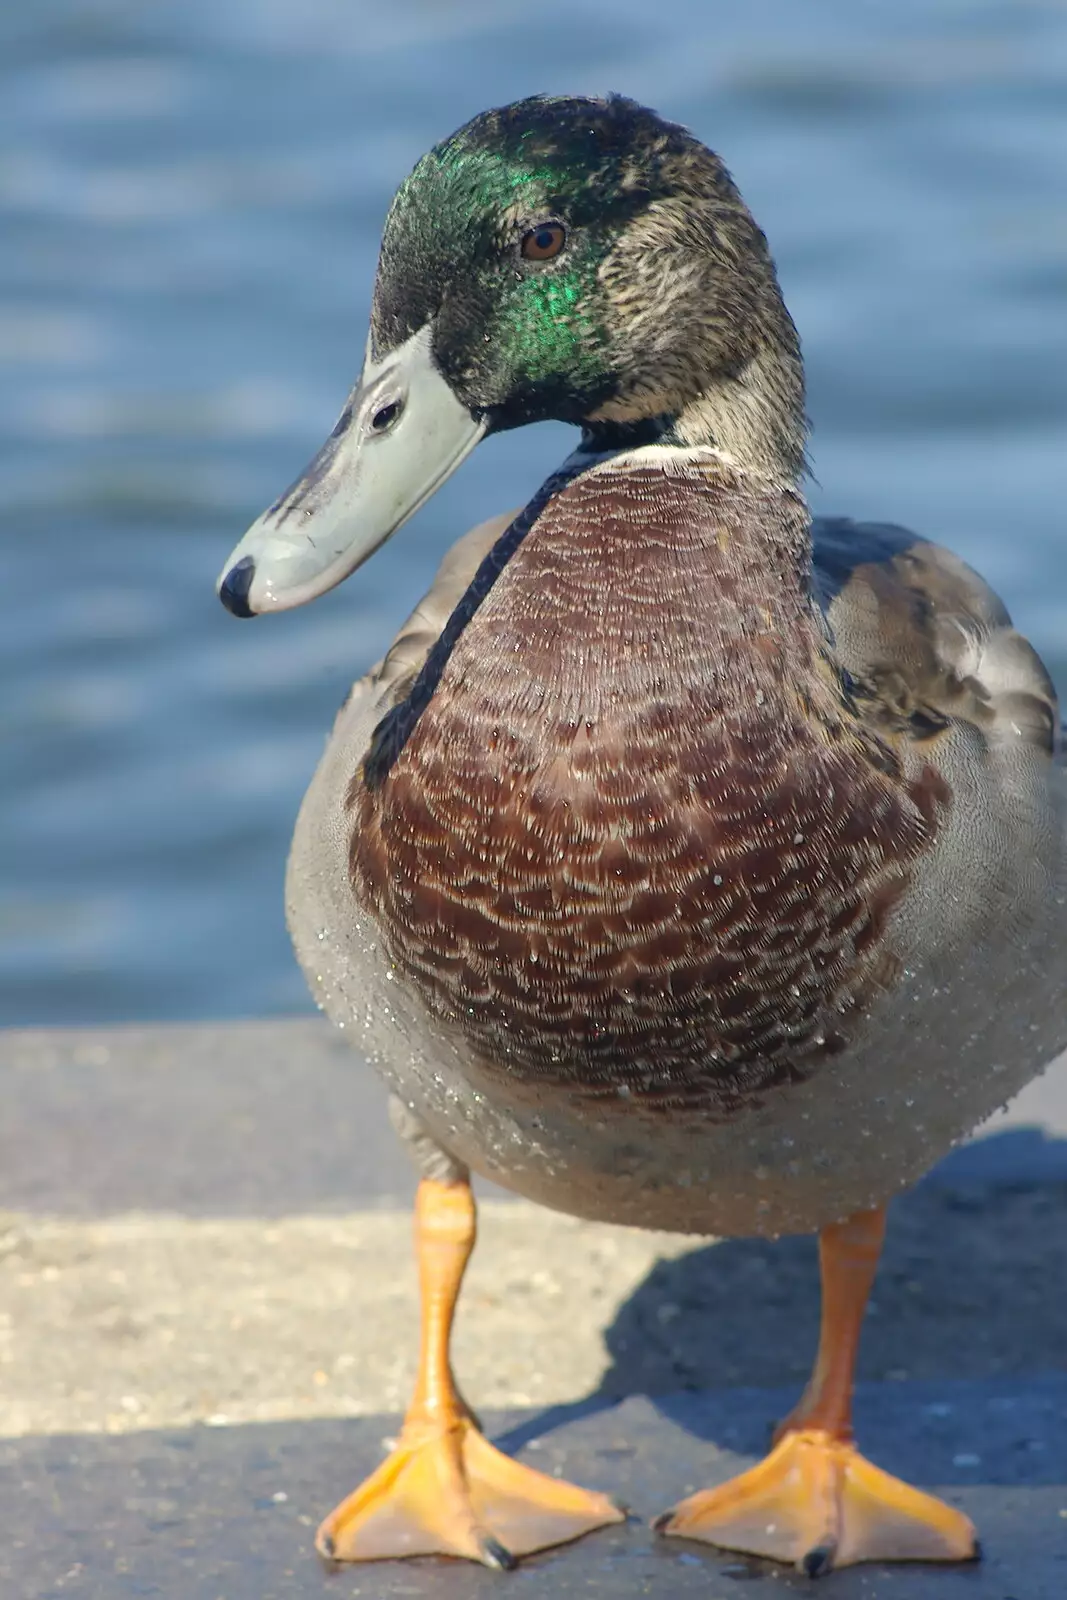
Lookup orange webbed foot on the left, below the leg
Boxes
[315,1418,625,1568]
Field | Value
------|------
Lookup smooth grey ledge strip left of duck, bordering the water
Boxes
[0,1018,414,1216]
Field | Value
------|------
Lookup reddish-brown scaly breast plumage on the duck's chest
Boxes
[347,451,950,1118]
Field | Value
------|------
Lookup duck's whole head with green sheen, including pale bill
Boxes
[219,96,805,616]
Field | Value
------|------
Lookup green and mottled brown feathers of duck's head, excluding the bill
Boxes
[371,96,805,477]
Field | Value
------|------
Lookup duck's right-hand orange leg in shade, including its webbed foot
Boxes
[656,1211,977,1578]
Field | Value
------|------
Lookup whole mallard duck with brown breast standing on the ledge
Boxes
[219,96,1067,1576]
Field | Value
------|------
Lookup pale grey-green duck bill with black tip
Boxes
[218,325,486,616]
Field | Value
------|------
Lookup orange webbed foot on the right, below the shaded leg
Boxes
[656,1429,977,1578]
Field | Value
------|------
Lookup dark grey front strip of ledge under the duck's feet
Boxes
[0,1378,1067,1600]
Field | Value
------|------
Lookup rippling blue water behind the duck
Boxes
[0,0,1067,1022]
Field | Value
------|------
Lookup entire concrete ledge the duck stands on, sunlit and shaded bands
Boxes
[0,1019,1067,1600]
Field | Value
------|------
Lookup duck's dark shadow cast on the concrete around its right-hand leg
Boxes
[498,1128,1067,1475]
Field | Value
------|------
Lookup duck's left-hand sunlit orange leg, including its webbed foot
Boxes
[315,1178,624,1566]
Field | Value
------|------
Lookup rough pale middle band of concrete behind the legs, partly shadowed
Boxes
[0,1186,1067,1446]
